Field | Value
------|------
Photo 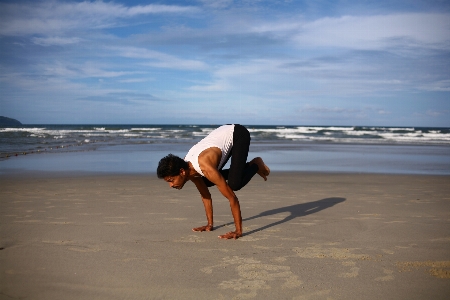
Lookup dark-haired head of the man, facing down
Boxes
[156,154,189,190]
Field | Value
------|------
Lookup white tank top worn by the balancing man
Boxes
[184,125,234,176]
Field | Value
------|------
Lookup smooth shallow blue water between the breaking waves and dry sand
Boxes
[0,143,450,175]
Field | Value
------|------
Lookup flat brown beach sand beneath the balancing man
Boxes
[0,172,450,300]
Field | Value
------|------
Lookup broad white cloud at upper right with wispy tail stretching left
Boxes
[207,13,450,50]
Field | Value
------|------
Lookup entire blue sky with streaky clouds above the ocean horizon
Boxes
[0,0,450,127]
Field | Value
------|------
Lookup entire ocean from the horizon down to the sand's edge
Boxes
[0,125,450,175]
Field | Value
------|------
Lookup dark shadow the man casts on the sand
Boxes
[214,197,345,236]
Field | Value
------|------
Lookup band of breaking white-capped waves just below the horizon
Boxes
[0,126,450,144]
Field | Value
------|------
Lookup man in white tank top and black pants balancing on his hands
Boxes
[157,124,270,239]
